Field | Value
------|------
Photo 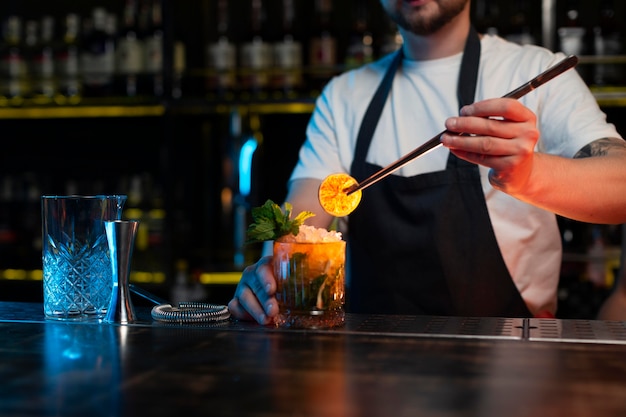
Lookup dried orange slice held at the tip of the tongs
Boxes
[318,174,361,217]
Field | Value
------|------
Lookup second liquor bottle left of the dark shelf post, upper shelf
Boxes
[116,0,144,97]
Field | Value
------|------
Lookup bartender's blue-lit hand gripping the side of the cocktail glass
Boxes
[228,256,278,325]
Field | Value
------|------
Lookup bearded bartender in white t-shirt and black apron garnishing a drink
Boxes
[229,0,626,324]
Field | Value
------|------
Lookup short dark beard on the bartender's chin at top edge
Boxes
[389,0,469,36]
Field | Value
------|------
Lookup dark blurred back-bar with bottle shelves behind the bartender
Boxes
[0,0,626,318]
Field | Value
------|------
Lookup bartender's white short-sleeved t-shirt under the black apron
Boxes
[291,36,620,313]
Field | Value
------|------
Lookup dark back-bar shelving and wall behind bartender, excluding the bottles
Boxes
[0,0,626,318]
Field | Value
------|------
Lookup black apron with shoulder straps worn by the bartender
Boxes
[346,28,531,317]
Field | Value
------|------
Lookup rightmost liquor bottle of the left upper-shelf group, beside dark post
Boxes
[142,0,165,97]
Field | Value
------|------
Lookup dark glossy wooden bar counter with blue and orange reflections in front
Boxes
[0,302,626,417]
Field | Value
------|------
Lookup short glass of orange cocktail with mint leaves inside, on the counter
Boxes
[274,226,346,328]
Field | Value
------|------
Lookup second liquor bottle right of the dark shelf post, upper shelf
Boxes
[240,0,272,98]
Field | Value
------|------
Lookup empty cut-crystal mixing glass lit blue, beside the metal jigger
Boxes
[41,195,126,320]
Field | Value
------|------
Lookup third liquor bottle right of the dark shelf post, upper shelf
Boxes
[272,0,303,98]
